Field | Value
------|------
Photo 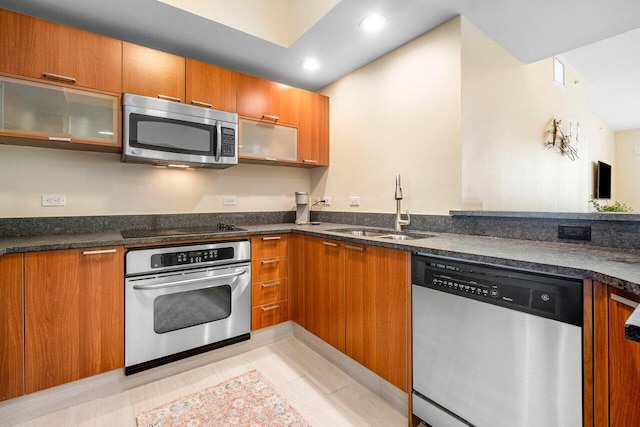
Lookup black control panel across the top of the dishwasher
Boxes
[411,254,583,326]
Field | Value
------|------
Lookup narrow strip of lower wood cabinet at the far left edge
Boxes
[0,254,24,401]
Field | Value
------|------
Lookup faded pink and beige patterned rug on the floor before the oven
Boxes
[136,370,310,427]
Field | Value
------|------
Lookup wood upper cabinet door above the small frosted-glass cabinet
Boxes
[237,74,301,126]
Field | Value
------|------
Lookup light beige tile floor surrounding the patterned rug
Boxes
[13,338,407,427]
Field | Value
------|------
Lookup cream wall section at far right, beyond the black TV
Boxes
[612,129,640,213]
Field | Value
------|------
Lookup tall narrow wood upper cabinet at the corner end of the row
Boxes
[298,90,329,166]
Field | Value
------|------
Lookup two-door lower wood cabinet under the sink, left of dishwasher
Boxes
[298,237,409,392]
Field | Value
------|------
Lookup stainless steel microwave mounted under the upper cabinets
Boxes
[122,93,238,169]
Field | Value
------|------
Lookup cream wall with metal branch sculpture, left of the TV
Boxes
[462,18,595,212]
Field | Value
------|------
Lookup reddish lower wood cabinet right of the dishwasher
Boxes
[594,282,640,427]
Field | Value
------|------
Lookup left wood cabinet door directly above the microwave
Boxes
[122,42,185,102]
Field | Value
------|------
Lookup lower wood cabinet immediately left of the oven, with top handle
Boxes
[24,246,124,393]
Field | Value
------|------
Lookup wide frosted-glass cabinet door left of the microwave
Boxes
[0,76,121,152]
